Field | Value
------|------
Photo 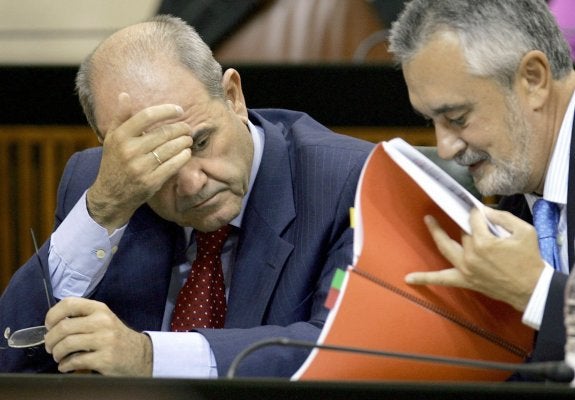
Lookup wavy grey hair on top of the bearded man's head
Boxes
[389,0,573,89]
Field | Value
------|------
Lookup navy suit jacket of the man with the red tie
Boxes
[0,109,373,376]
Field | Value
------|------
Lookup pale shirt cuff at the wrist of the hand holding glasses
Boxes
[144,331,218,378]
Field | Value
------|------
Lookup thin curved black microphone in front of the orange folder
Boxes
[226,337,575,382]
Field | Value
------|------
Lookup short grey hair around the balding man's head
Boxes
[76,15,224,137]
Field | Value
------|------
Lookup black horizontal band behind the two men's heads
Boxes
[0,64,423,126]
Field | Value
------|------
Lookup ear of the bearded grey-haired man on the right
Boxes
[517,50,553,110]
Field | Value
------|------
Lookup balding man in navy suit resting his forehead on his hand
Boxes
[0,16,373,377]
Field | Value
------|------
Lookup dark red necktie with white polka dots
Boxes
[170,225,230,332]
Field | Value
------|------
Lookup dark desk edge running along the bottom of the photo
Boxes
[0,374,575,400]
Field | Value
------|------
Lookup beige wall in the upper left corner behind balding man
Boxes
[0,0,160,65]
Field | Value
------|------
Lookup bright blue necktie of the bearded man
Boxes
[533,199,561,271]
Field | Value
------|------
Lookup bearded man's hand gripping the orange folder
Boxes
[405,208,544,311]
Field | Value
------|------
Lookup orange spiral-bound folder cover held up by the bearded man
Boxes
[293,145,534,381]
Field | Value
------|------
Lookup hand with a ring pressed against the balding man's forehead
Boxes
[87,93,192,233]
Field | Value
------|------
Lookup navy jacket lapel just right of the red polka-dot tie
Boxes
[226,114,295,327]
